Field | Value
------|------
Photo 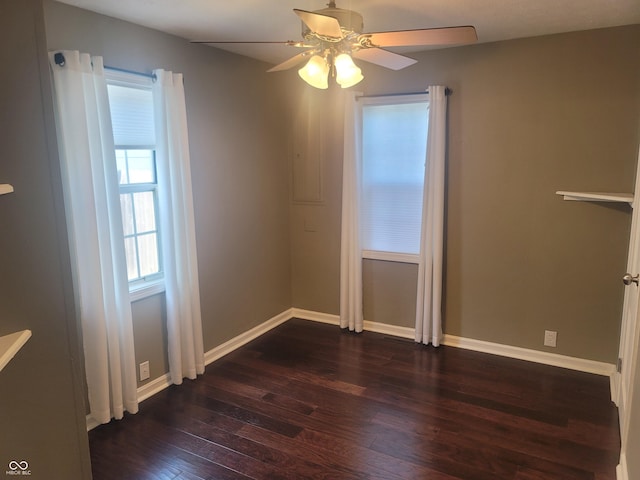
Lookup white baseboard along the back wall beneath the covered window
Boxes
[292,308,616,380]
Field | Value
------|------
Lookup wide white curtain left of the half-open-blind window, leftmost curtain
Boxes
[50,51,138,423]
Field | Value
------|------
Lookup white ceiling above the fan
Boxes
[53,0,640,64]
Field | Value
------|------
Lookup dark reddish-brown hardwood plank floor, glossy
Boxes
[89,320,620,480]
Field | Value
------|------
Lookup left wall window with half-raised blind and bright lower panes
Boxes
[107,71,162,293]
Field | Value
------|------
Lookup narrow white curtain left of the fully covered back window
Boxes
[340,92,363,332]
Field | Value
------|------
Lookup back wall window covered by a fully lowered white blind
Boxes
[360,95,429,263]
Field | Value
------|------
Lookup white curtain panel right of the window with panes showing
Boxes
[153,70,204,385]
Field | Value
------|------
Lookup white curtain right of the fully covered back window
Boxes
[415,85,447,346]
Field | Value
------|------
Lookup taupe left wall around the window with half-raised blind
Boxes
[45,1,291,388]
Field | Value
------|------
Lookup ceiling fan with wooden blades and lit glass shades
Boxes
[192,0,478,89]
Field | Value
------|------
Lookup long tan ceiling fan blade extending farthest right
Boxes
[358,26,478,47]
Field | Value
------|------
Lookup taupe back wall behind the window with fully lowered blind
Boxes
[292,26,640,363]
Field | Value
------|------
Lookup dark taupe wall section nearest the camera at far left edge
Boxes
[0,0,91,479]
